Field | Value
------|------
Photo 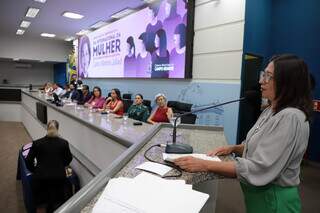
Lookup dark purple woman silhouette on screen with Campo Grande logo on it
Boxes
[151,29,170,78]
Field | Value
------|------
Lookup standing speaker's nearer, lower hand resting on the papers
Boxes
[174,156,208,172]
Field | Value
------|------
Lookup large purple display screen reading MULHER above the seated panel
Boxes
[78,0,194,78]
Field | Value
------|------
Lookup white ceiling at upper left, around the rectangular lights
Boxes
[0,0,144,40]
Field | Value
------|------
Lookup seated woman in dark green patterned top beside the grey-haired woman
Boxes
[128,94,150,122]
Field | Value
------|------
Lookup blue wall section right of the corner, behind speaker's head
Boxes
[271,0,320,99]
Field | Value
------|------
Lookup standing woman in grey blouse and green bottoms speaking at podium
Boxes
[175,55,312,213]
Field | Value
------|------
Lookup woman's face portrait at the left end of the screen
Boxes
[79,36,91,78]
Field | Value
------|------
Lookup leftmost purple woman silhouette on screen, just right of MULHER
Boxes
[123,36,137,77]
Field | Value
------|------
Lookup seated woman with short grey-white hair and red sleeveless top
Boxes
[148,93,173,124]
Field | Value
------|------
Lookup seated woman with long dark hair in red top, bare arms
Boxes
[103,88,124,116]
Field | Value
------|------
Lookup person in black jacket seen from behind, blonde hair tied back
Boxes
[26,120,72,212]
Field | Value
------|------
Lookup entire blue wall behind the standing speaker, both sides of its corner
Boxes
[244,0,320,161]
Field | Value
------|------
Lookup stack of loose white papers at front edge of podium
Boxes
[93,172,209,213]
